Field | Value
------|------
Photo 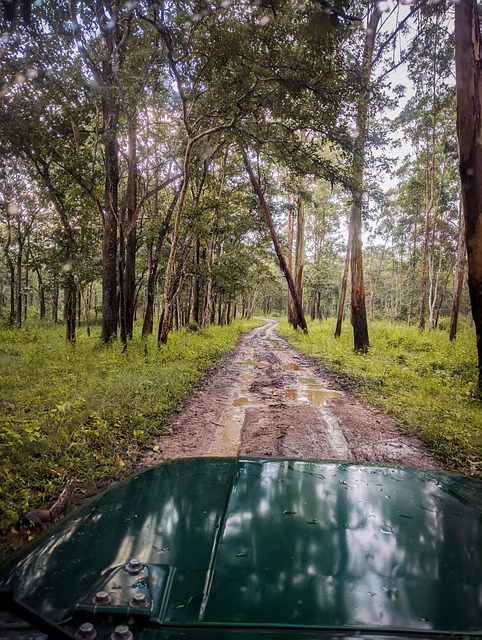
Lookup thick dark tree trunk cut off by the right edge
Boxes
[455,0,482,395]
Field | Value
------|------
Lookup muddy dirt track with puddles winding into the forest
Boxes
[137,320,442,469]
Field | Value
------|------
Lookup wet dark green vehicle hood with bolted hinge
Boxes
[0,458,482,640]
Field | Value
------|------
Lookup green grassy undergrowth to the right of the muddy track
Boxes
[278,321,482,473]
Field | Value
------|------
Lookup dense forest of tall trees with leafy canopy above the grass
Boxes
[0,0,482,382]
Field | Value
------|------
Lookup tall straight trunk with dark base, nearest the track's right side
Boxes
[350,5,382,353]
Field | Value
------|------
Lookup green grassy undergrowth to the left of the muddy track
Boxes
[0,320,261,546]
